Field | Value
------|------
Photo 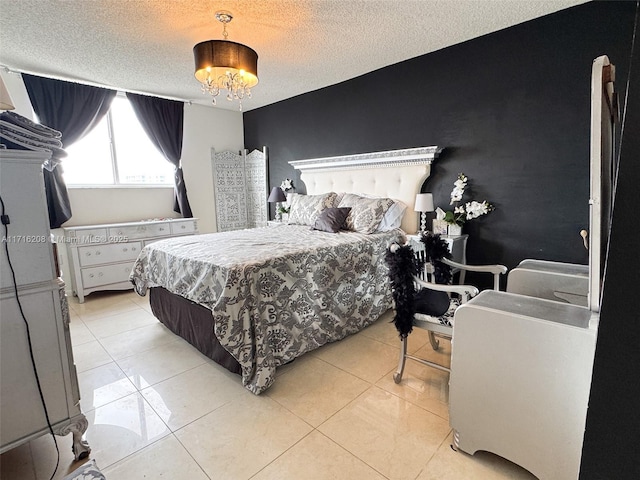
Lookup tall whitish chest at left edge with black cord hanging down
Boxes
[0,150,90,459]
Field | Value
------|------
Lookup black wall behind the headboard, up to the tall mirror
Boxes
[244,2,635,276]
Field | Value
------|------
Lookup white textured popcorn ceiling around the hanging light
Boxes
[0,0,585,111]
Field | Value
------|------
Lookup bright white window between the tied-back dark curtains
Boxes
[62,94,174,185]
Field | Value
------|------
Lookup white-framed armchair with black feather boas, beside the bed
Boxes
[385,233,507,383]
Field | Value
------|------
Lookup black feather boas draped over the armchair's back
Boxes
[384,232,451,338]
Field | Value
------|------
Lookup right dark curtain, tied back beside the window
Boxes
[127,93,193,218]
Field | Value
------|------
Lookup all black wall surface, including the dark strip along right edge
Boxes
[244,1,640,480]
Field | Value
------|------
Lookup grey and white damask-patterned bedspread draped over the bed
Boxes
[131,225,404,394]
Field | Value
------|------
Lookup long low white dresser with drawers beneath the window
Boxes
[61,218,198,303]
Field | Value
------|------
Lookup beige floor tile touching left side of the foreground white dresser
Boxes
[318,386,450,480]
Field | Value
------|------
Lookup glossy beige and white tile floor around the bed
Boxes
[0,292,535,480]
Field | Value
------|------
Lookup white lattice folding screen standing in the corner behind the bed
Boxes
[211,147,269,232]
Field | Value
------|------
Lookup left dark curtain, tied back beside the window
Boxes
[22,73,116,228]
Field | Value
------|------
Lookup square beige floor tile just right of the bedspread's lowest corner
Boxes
[265,355,370,427]
